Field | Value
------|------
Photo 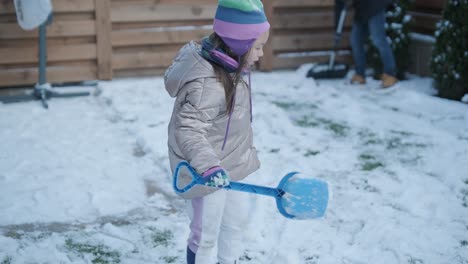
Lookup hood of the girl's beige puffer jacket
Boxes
[164,41,216,97]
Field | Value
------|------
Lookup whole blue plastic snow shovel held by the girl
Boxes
[173,161,329,219]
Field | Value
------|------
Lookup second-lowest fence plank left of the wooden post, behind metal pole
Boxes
[0,44,97,64]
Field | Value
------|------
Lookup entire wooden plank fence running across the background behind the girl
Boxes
[0,0,443,87]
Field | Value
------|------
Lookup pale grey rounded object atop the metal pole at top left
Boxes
[14,0,52,30]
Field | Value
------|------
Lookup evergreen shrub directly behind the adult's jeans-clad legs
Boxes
[367,0,412,80]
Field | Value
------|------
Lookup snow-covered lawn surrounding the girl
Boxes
[0,66,468,264]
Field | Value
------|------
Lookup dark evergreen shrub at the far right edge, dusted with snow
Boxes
[431,0,468,100]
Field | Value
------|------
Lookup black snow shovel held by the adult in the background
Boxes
[307,5,348,79]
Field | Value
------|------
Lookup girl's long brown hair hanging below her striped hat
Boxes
[204,33,249,113]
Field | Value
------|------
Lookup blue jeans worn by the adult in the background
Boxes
[351,11,396,76]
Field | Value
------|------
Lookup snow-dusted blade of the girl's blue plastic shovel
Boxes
[276,173,329,219]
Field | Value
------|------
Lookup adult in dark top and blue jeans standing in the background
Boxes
[348,0,398,89]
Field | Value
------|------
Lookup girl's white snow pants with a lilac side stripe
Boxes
[187,189,250,264]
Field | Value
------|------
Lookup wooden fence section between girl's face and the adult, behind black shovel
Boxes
[260,0,352,70]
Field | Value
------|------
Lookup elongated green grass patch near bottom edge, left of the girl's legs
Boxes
[65,239,120,264]
